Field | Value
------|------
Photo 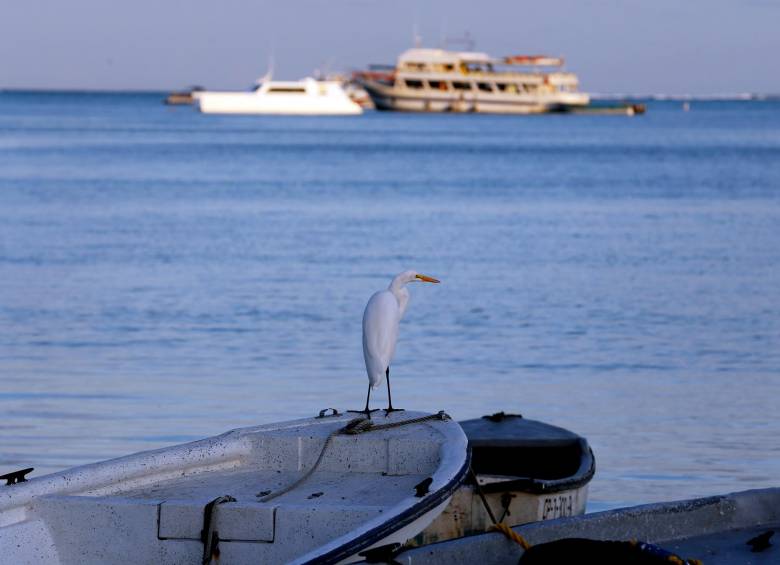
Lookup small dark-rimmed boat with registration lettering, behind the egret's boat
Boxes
[414,412,596,545]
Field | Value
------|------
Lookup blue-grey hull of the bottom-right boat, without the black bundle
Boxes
[378,488,780,565]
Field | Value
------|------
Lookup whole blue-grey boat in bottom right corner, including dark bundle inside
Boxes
[386,488,780,565]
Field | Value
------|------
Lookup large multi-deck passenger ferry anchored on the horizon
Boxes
[355,48,590,114]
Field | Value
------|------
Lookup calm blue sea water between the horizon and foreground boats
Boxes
[0,93,780,508]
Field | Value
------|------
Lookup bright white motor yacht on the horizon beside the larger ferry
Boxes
[193,78,363,116]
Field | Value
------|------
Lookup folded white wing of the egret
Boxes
[363,290,400,386]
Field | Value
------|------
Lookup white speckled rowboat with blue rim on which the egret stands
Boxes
[0,412,469,565]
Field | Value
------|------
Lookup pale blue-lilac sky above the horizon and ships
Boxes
[0,0,780,94]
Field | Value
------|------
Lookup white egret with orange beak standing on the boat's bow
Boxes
[362,271,439,418]
